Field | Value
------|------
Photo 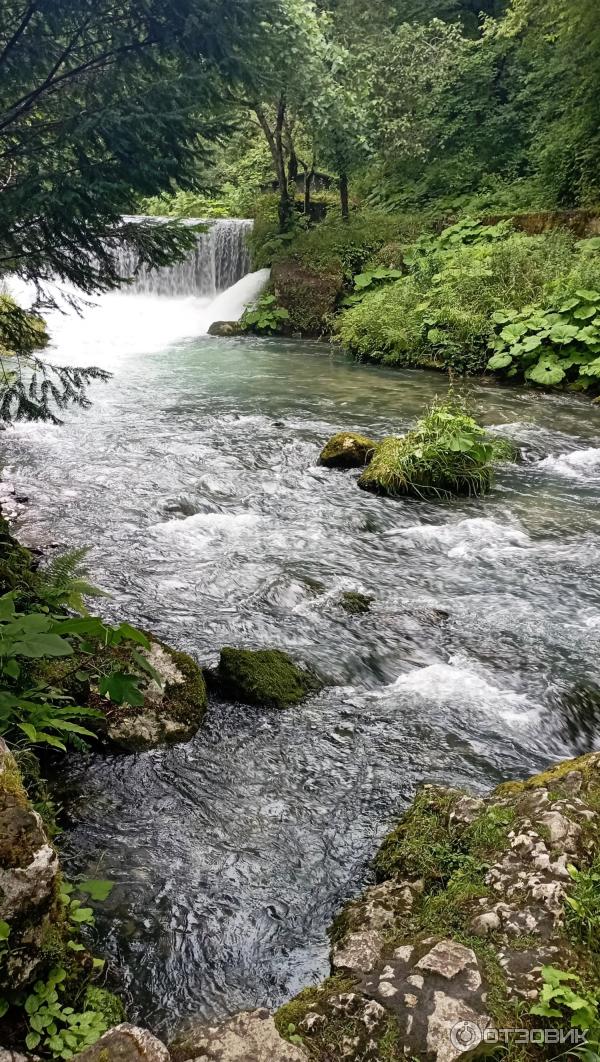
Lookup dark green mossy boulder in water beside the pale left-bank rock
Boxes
[215,647,323,708]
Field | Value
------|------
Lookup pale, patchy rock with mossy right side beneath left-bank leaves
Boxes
[106,641,207,752]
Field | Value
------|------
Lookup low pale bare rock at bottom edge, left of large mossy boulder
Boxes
[171,1010,308,1062]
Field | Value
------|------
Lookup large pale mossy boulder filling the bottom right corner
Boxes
[269,753,600,1062]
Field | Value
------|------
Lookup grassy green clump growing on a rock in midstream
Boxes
[358,395,509,498]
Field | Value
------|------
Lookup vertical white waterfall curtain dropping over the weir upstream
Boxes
[120,218,253,297]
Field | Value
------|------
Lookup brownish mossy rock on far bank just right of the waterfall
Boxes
[272,258,344,336]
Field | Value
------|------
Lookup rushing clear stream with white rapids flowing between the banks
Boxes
[2,228,600,1030]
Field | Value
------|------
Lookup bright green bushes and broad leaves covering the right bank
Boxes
[336,222,600,387]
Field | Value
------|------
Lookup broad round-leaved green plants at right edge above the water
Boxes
[487,288,600,390]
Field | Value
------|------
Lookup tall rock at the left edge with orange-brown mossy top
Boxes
[0,738,58,990]
